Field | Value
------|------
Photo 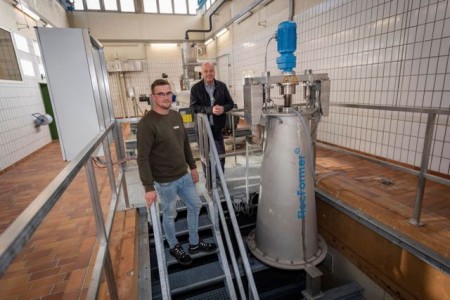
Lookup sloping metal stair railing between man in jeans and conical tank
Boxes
[197,114,259,299]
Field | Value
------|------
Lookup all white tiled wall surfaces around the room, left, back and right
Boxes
[0,0,450,174]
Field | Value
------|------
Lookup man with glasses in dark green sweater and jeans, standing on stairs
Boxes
[137,79,216,265]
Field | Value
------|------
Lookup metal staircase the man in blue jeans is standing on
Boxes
[150,196,236,299]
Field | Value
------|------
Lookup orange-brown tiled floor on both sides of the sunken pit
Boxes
[0,142,450,299]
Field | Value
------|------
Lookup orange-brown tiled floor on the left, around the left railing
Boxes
[0,142,136,299]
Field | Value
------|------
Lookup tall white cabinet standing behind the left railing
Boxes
[36,27,114,160]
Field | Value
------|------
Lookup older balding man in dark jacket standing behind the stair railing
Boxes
[190,61,234,176]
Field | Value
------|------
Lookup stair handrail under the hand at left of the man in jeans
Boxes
[147,201,172,300]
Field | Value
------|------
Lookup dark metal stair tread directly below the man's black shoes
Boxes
[169,261,225,295]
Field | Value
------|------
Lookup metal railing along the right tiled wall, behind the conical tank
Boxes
[317,103,450,226]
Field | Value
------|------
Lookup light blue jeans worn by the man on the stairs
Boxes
[155,173,202,249]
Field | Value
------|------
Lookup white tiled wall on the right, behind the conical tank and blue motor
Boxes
[225,0,450,174]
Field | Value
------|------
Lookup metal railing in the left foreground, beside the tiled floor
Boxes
[0,121,129,299]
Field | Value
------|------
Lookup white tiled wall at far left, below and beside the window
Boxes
[0,33,51,170]
